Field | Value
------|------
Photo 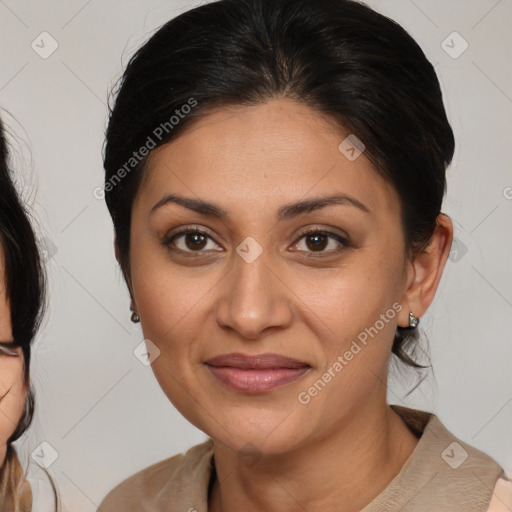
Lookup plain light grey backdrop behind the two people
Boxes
[0,0,512,512]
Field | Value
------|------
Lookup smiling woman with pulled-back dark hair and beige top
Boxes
[99,0,512,512]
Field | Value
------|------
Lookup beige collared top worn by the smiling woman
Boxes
[98,405,512,512]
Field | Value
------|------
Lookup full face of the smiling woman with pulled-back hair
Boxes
[130,100,416,453]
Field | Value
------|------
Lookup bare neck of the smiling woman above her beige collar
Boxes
[208,399,418,512]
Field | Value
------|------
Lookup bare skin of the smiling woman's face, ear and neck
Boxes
[128,99,453,512]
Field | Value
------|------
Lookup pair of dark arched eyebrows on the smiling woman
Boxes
[150,194,371,221]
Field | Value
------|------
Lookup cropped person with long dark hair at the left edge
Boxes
[0,120,57,512]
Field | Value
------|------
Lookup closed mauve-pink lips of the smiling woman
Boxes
[205,353,311,393]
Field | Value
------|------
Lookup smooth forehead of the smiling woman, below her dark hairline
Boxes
[137,100,398,219]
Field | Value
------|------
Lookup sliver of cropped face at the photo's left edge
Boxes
[0,247,27,466]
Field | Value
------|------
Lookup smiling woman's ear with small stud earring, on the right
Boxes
[398,213,453,327]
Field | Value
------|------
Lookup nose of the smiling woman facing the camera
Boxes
[215,244,293,340]
